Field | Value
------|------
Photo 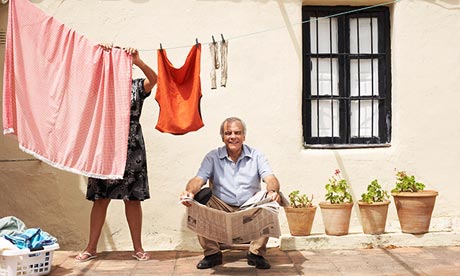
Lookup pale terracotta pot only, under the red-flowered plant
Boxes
[319,202,353,236]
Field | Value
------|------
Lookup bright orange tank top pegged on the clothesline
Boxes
[155,43,204,135]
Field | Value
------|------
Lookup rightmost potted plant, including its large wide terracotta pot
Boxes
[391,171,438,234]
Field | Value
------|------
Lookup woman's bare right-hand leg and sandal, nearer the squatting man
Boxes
[124,200,148,259]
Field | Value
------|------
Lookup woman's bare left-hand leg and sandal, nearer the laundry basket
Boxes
[76,199,110,261]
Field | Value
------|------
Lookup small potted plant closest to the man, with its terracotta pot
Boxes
[284,190,316,236]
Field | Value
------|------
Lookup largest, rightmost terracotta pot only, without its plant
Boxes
[391,190,438,234]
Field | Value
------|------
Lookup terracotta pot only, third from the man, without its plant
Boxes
[358,200,390,235]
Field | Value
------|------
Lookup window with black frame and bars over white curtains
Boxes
[302,6,391,148]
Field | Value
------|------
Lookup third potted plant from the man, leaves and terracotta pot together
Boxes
[358,179,390,235]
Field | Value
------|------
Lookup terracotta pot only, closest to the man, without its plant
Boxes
[284,206,316,236]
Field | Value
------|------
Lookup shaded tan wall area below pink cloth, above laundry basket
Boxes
[0,160,91,249]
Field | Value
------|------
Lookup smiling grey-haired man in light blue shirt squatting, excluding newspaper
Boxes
[180,117,281,269]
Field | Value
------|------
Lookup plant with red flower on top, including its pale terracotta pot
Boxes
[319,169,353,236]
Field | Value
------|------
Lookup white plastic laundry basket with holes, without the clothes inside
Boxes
[0,243,59,276]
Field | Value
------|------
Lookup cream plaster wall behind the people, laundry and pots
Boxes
[0,0,460,250]
